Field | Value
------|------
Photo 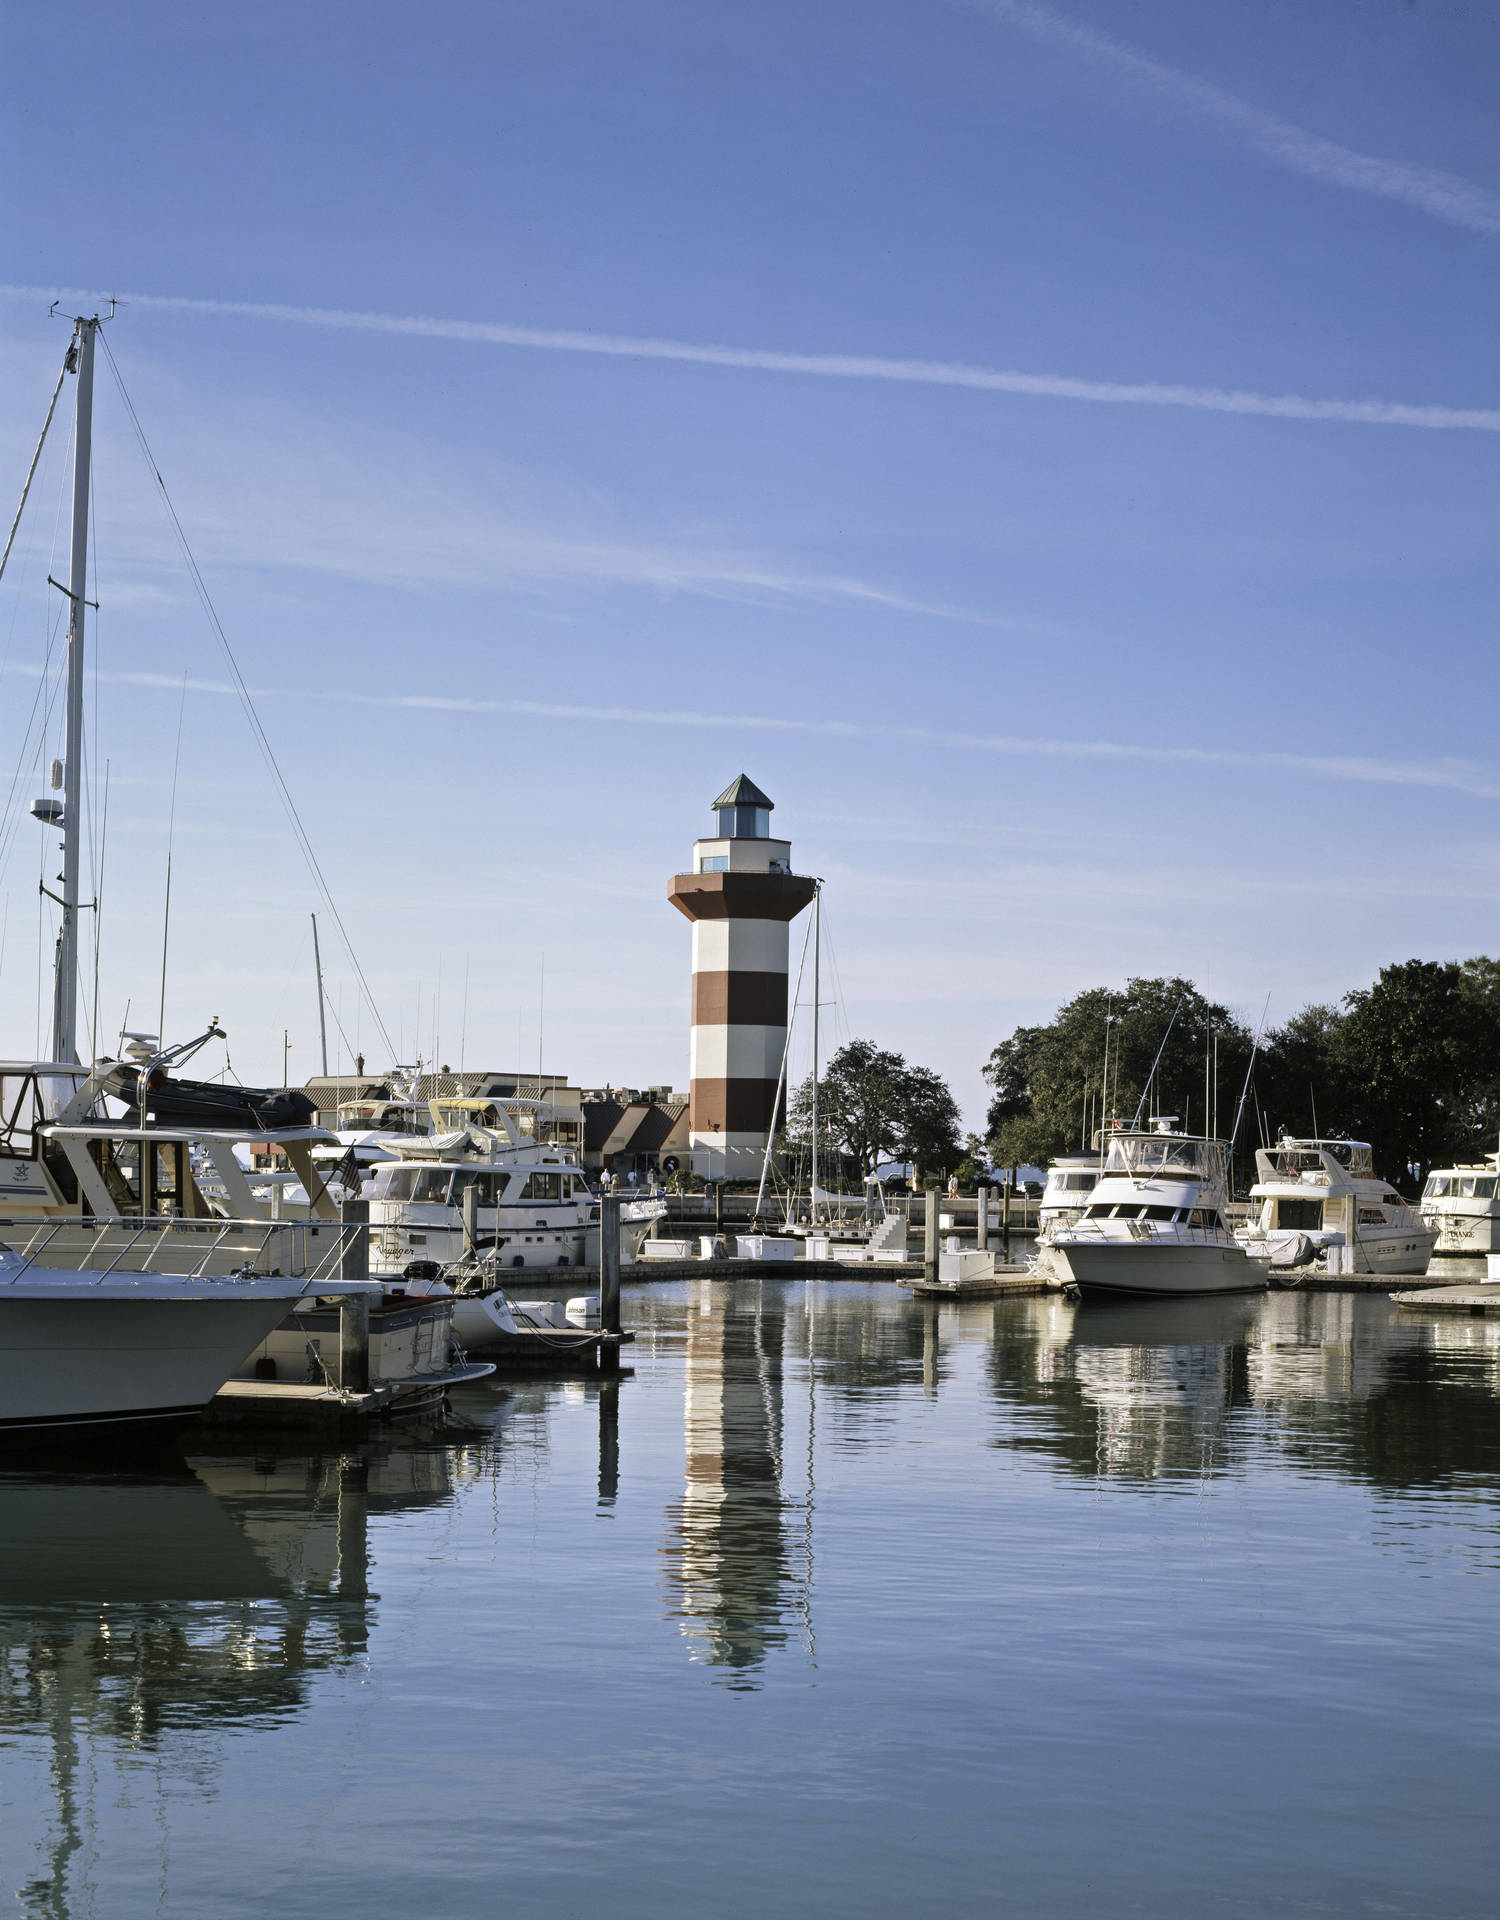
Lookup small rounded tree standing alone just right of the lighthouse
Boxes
[787,1041,964,1175]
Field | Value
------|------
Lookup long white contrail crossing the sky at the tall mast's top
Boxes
[0,286,1500,434]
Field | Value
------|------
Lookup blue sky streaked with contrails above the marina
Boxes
[0,0,1500,1123]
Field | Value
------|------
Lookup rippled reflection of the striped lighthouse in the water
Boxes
[666,1281,805,1684]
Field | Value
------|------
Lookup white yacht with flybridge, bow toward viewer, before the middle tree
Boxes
[1051,1116,1268,1296]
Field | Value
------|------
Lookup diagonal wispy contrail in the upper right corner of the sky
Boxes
[966,0,1500,234]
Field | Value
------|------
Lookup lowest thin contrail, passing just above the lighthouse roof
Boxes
[8,662,1500,801]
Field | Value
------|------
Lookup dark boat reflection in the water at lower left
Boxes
[0,1448,451,1920]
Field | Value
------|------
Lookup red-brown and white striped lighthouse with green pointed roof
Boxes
[666,774,816,1181]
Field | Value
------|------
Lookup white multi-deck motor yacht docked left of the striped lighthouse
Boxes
[367,1098,666,1277]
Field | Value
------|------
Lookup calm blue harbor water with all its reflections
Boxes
[0,1281,1500,1920]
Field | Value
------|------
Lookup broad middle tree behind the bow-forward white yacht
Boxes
[983,977,1252,1167]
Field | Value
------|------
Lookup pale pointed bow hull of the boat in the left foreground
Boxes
[0,1248,307,1444]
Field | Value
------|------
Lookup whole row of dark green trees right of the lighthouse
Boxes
[784,956,1500,1190]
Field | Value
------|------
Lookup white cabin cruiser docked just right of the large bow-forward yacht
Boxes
[1237,1135,1436,1273]
